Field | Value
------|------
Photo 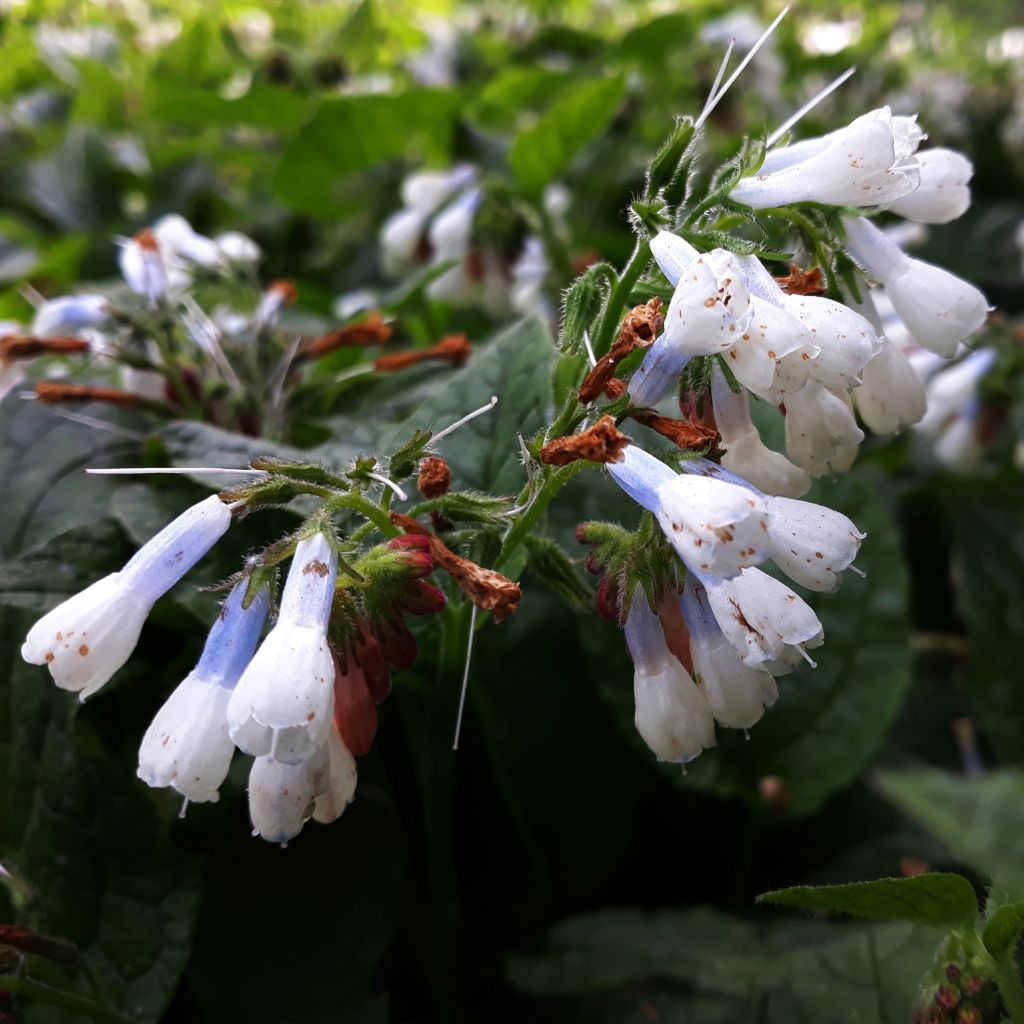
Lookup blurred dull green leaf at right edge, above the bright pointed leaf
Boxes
[879,769,1024,894]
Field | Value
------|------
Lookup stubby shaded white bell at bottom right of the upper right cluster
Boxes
[785,381,864,476]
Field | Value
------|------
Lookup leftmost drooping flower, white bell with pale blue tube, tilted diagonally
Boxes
[22,495,231,700]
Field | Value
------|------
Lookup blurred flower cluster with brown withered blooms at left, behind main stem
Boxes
[0,215,479,440]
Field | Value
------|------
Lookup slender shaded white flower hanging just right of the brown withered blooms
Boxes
[711,367,811,498]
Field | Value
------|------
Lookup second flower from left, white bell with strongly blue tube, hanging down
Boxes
[138,580,270,804]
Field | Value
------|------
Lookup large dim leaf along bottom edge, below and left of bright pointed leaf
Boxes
[509,907,934,1024]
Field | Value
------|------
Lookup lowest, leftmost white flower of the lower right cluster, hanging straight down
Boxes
[626,593,715,763]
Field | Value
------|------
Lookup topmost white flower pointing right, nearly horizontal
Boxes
[730,106,924,210]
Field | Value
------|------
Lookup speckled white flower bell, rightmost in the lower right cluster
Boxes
[766,498,866,591]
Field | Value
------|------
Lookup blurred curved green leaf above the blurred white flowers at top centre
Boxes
[273,89,458,216]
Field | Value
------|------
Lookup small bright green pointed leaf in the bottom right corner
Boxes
[758,872,978,928]
